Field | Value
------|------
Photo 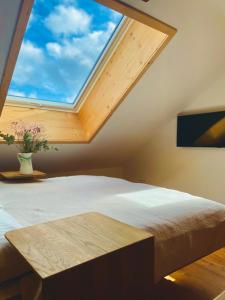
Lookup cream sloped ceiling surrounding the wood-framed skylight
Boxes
[0,0,225,171]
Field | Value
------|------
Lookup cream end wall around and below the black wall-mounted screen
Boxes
[125,75,225,204]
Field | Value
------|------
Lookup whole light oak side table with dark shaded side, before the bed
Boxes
[6,213,154,300]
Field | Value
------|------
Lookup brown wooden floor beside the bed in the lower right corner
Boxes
[7,248,225,300]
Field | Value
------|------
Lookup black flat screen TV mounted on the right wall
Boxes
[177,111,225,147]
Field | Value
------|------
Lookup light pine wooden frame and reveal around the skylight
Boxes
[0,0,176,143]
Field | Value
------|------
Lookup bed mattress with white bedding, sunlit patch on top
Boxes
[0,176,225,282]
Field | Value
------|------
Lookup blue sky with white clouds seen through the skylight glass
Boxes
[8,0,122,104]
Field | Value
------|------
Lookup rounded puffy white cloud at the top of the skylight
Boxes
[44,5,91,35]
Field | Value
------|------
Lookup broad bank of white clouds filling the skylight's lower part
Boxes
[11,11,116,103]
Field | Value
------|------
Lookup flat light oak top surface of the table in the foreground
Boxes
[5,213,153,279]
